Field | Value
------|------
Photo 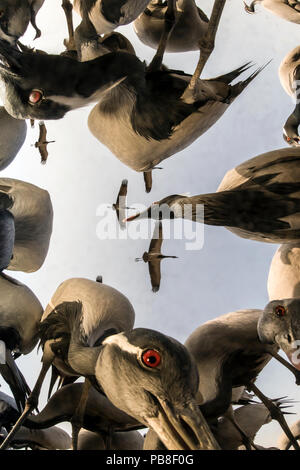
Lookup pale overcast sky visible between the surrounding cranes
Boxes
[2,0,300,446]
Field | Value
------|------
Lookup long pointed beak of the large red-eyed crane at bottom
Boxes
[147,398,220,450]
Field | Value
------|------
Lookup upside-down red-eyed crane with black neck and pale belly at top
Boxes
[0,42,261,171]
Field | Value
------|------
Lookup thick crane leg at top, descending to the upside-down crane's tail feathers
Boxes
[182,0,226,102]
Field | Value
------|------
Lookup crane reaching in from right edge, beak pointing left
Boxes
[127,148,300,243]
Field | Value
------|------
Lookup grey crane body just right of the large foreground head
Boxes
[185,309,278,419]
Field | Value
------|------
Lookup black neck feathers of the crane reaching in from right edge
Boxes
[185,164,300,235]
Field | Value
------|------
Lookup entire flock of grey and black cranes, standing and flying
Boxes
[0,0,300,450]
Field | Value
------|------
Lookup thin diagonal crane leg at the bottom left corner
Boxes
[0,360,52,450]
